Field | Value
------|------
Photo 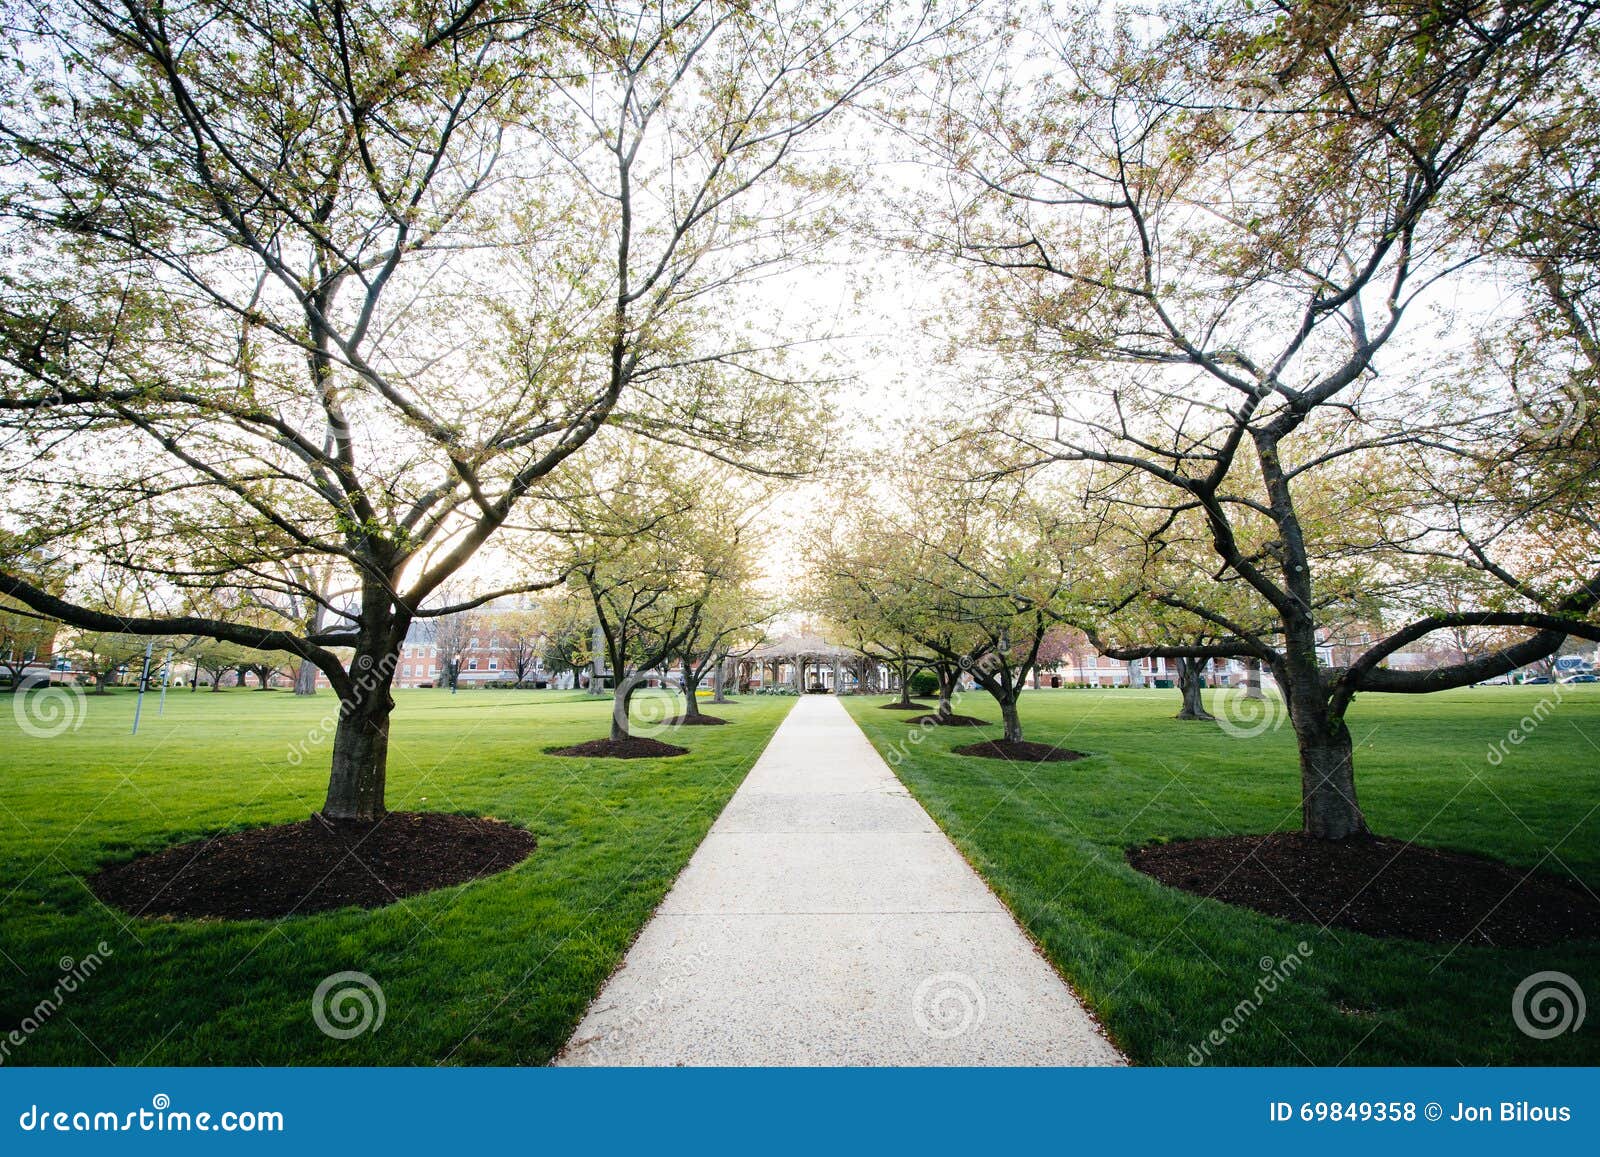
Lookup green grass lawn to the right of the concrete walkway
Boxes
[846,685,1600,1064]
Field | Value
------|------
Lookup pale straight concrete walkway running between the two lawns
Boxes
[557,695,1123,1064]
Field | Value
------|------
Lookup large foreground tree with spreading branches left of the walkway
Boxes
[0,0,902,821]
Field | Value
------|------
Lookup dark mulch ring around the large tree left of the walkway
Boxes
[91,811,536,920]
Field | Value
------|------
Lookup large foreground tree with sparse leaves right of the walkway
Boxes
[923,3,1600,840]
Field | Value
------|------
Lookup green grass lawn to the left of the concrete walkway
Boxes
[0,690,794,1064]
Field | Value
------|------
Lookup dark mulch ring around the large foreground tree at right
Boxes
[1128,832,1600,947]
